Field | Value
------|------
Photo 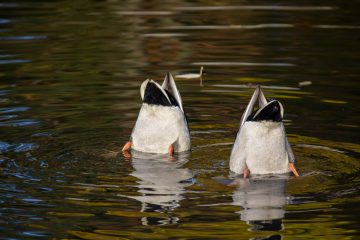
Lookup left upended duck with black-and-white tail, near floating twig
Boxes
[122,72,191,155]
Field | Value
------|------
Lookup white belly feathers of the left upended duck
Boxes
[131,103,191,153]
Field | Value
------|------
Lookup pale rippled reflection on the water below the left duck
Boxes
[128,151,195,225]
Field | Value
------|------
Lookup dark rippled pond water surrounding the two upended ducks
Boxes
[0,0,360,240]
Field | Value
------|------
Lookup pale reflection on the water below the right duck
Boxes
[233,176,288,231]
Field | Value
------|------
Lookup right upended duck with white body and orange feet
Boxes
[230,86,299,178]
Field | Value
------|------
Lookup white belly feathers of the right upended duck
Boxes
[230,121,290,174]
